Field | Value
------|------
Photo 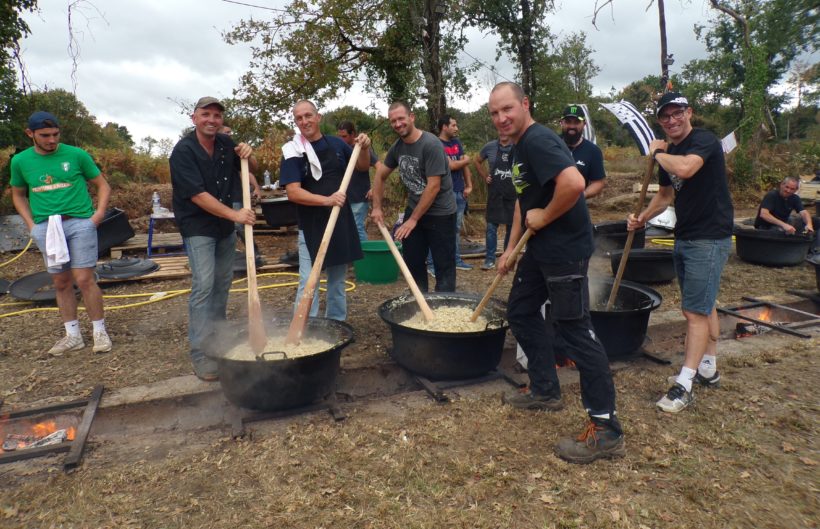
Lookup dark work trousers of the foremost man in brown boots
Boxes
[507,252,615,415]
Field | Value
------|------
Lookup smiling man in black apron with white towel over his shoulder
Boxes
[279,100,370,321]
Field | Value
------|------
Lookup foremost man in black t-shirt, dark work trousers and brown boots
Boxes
[489,82,625,463]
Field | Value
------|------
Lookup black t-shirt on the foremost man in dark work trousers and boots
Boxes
[513,123,593,263]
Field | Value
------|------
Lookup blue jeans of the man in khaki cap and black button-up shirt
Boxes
[183,232,236,360]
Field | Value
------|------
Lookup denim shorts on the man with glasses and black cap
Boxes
[673,237,732,316]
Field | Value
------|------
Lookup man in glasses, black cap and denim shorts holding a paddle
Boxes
[627,92,734,413]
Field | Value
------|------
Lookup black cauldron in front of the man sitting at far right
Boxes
[734,226,814,266]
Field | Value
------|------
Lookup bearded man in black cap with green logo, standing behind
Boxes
[561,105,606,200]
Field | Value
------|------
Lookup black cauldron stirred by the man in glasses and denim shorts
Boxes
[589,278,662,360]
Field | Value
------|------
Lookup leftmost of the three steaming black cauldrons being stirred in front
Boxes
[206,318,353,411]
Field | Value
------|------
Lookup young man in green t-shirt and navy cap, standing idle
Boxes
[11,111,111,356]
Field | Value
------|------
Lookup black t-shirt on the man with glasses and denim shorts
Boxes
[658,129,734,241]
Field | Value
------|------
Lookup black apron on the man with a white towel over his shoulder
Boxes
[297,136,363,268]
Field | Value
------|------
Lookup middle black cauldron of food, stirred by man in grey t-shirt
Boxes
[379,292,507,380]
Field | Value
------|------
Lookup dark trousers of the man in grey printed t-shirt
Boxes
[402,209,456,292]
